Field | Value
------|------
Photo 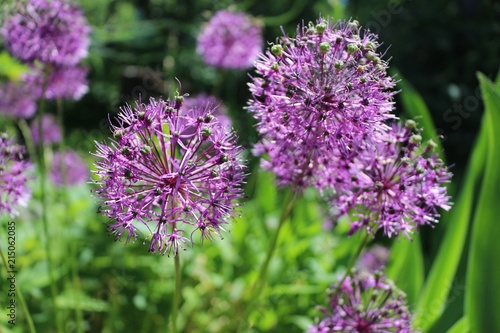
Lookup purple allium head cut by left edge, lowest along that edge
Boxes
[0,133,32,217]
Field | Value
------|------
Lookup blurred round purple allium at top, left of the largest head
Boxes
[197,10,263,69]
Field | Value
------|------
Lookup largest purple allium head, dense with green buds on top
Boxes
[248,18,394,190]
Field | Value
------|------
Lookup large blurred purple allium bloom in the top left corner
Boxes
[2,0,90,66]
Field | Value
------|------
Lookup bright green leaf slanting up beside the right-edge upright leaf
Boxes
[414,105,488,331]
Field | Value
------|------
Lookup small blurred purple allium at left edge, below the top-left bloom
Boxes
[0,82,37,118]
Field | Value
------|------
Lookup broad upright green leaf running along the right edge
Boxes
[465,74,500,333]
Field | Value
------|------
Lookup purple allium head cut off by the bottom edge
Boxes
[308,272,417,333]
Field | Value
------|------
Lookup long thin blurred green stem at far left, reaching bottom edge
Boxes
[37,75,63,332]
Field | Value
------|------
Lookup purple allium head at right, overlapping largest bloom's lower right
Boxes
[332,120,452,237]
